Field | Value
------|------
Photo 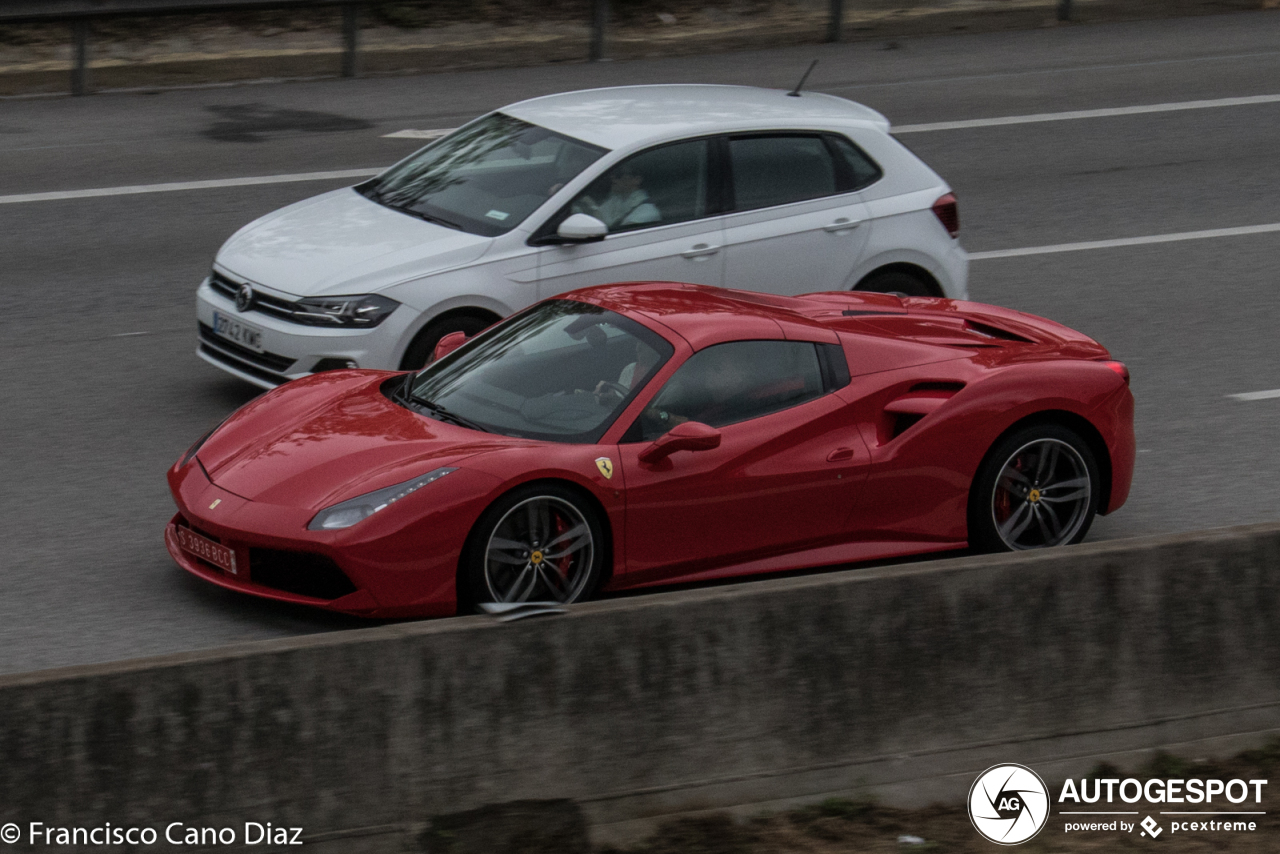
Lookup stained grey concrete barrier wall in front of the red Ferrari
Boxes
[0,525,1280,851]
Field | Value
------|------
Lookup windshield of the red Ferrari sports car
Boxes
[408,300,675,443]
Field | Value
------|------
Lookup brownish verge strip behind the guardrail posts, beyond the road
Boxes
[0,0,1271,95]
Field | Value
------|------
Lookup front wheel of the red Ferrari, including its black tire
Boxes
[458,483,608,613]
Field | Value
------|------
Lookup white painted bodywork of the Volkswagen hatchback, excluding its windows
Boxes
[197,85,968,388]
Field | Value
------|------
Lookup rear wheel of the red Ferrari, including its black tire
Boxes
[969,424,1102,552]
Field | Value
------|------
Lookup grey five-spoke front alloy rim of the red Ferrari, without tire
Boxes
[483,494,598,603]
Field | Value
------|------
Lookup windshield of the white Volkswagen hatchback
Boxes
[356,113,605,237]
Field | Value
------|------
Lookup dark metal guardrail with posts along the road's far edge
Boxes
[0,0,1071,95]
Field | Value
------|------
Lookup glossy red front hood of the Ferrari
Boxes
[196,371,530,510]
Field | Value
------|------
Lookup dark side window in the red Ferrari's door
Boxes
[640,341,829,440]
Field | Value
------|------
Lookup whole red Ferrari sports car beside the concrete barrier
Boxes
[165,283,1134,617]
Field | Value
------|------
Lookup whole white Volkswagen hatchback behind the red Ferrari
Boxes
[197,86,969,388]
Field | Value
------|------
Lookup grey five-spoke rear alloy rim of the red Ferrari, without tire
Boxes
[989,437,1096,552]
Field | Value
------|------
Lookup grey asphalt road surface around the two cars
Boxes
[0,13,1280,672]
